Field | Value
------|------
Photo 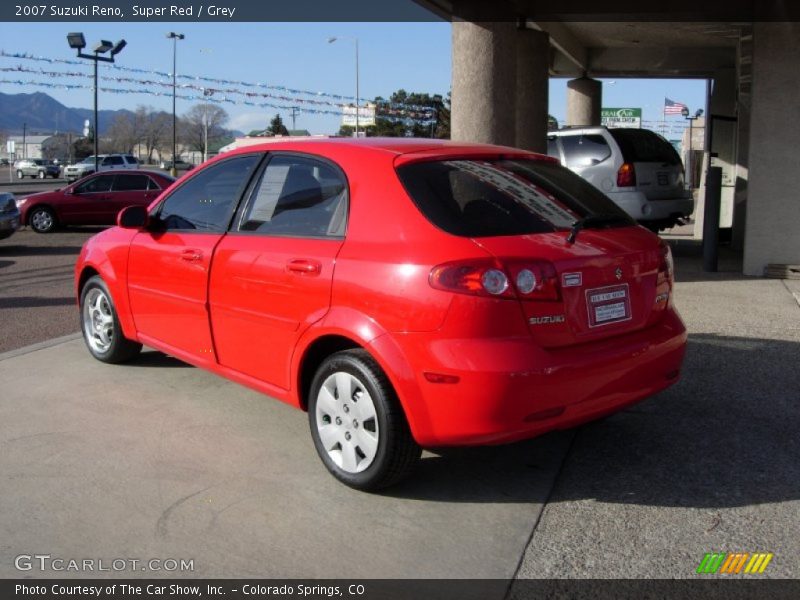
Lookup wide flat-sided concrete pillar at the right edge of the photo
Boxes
[744,23,800,276]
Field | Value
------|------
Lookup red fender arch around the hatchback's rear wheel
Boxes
[291,307,430,438]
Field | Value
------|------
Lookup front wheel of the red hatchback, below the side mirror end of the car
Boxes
[80,275,142,363]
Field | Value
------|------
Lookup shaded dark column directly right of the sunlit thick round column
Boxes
[515,29,550,154]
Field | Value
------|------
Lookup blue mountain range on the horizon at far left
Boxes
[0,92,139,135]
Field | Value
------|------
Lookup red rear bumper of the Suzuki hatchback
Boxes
[382,310,687,446]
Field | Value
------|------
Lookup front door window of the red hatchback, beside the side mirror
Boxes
[158,154,261,231]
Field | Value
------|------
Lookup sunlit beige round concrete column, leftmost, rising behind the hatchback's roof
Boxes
[450,21,517,146]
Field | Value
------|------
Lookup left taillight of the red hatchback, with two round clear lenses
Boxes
[428,259,560,301]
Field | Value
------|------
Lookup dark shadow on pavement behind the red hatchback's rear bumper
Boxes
[388,334,800,508]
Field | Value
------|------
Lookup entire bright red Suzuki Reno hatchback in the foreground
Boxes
[75,138,686,490]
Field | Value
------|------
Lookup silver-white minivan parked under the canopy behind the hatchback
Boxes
[547,127,694,231]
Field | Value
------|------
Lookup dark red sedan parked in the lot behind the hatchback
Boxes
[17,170,175,233]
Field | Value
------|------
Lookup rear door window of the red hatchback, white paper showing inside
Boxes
[238,155,347,237]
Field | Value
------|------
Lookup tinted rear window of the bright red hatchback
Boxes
[397,158,633,237]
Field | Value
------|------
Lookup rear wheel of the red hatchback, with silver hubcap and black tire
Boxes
[308,349,422,491]
